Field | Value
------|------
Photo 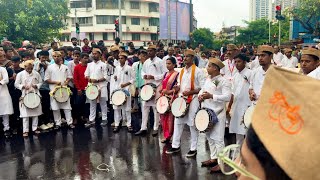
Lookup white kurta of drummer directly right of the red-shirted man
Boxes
[84,61,109,100]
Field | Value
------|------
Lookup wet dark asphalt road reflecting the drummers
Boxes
[0,112,235,180]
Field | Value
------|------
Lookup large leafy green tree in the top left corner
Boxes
[0,0,69,43]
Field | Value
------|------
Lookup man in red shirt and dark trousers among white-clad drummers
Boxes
[73,53,89,122]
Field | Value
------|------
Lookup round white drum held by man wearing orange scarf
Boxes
[171,97,189,118]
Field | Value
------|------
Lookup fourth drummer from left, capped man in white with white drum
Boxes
[111,52,135,133]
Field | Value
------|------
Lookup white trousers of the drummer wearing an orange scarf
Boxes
[172,124,199,151]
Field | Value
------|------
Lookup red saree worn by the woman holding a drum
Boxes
[160,71,179,139]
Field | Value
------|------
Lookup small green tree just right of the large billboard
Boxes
[191,28,214,49]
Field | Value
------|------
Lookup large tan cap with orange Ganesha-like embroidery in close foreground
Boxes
[251,66,320,179]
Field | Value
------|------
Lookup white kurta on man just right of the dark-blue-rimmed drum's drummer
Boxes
[229,68,252,135]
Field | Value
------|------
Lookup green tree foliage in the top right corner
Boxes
[288,0,320,36]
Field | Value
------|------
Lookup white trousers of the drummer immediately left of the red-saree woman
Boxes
[140,105,160,131]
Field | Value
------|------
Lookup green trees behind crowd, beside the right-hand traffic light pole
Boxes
[236,18,290,45]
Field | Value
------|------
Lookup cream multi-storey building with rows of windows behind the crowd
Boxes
[61,0,159,46]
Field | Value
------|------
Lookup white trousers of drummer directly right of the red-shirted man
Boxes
[89,97,108,122]
